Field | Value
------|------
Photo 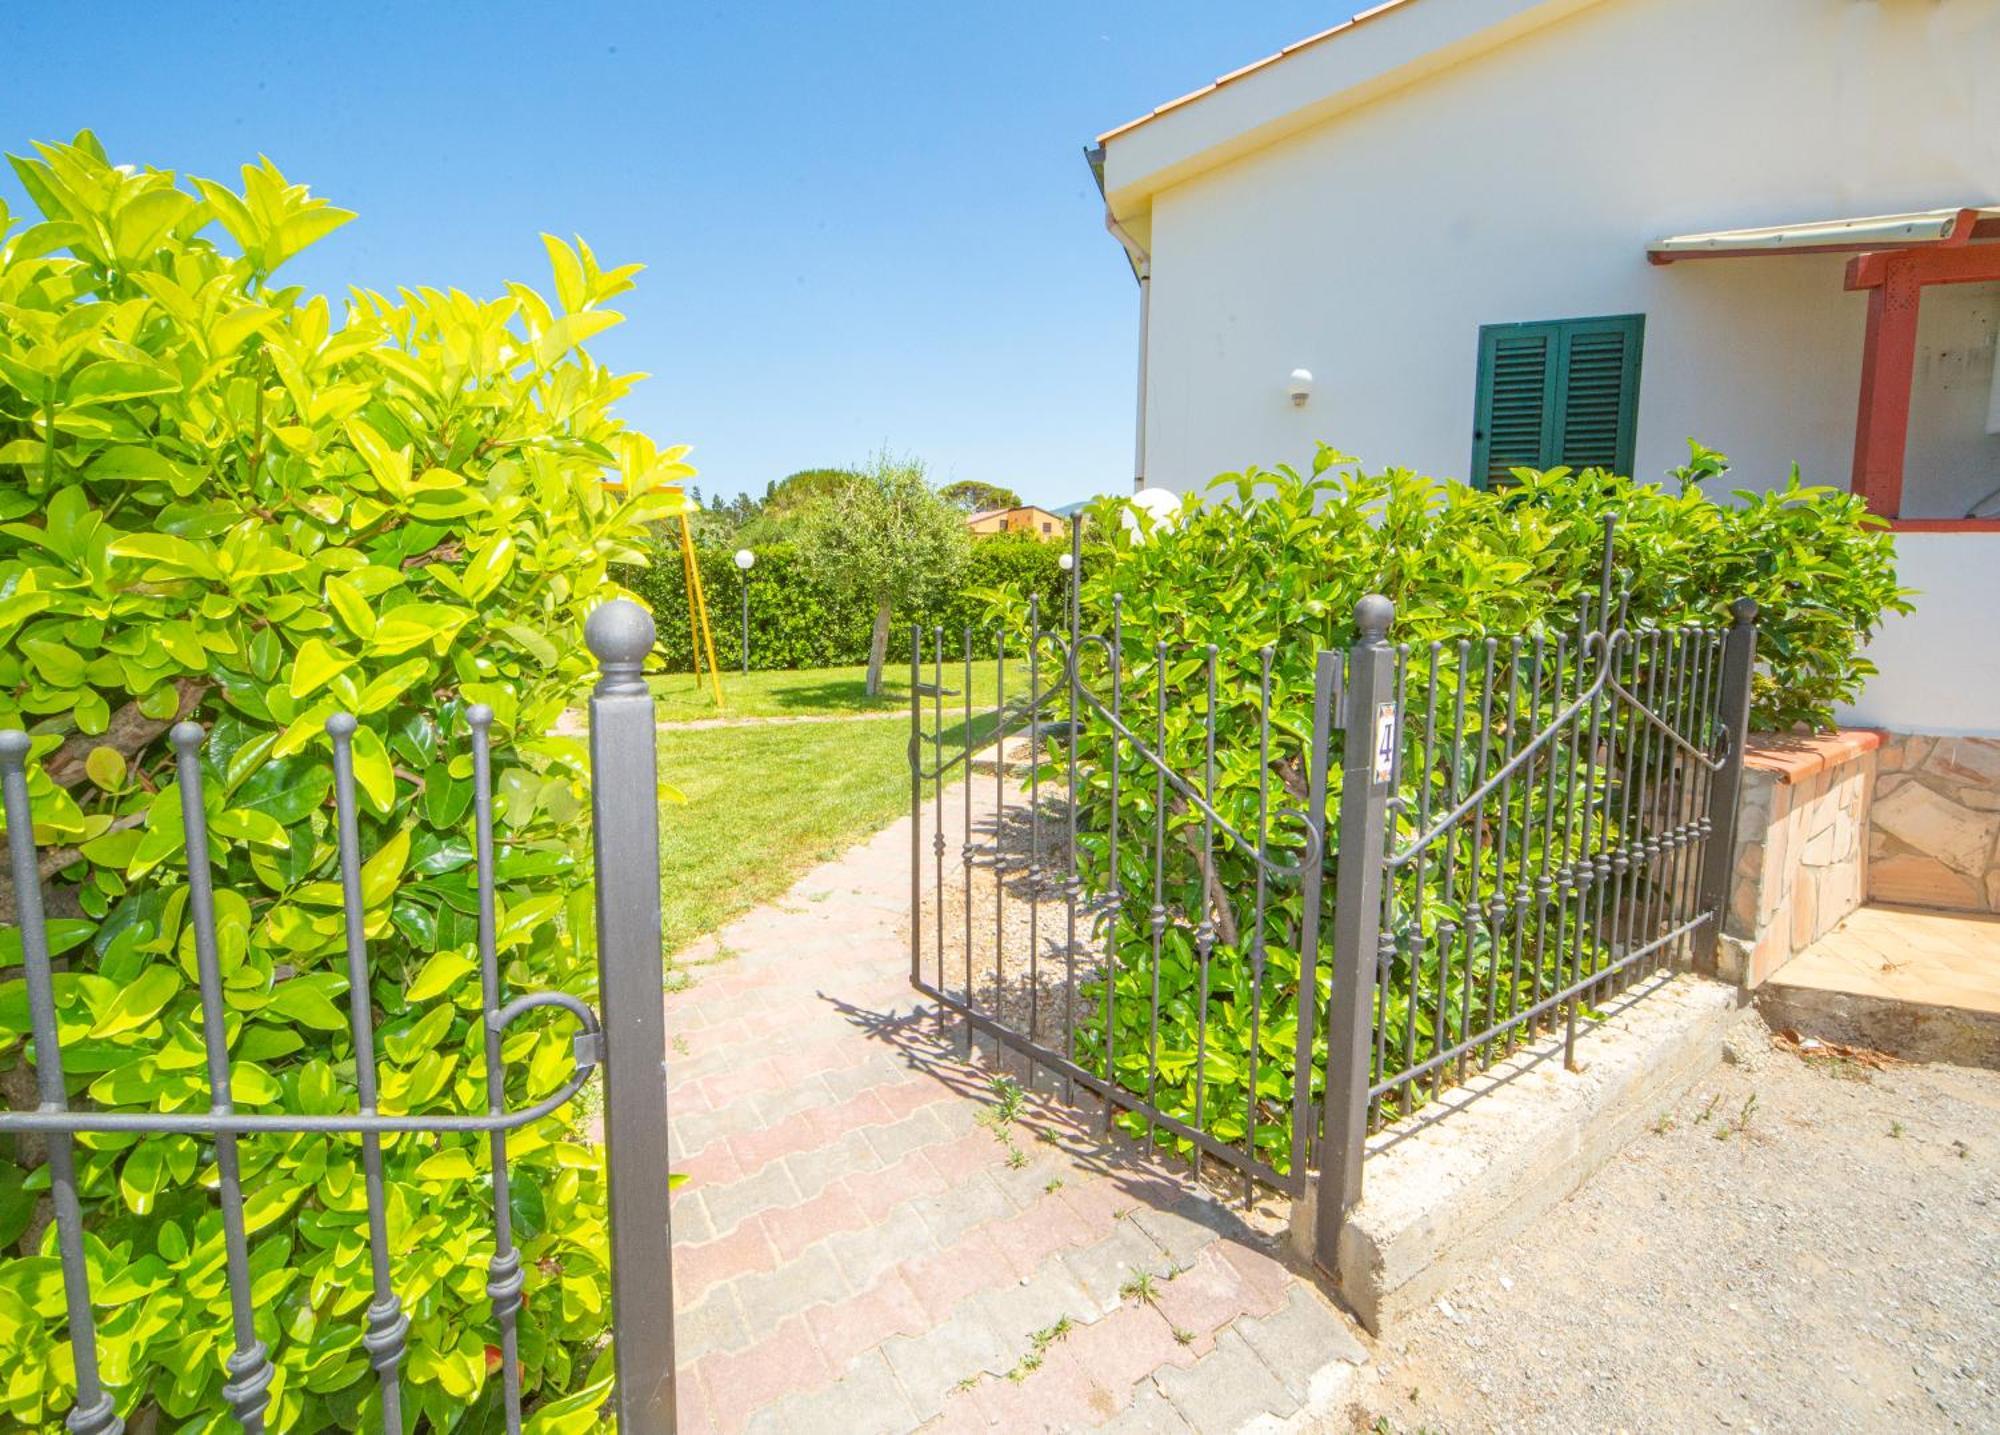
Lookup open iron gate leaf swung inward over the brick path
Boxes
[910,542,1334,1201]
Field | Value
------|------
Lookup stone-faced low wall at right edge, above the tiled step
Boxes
[1868,733,2000,911]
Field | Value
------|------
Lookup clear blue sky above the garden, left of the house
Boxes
[0,0,1346,504]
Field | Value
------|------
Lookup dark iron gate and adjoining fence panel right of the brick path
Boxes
[910,524,1756,1261]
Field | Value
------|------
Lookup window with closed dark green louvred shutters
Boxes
[1472,314,1646,488]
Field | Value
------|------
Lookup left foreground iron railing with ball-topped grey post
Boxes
[0,600,674,1435]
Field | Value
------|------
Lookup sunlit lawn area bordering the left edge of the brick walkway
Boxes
[660,695,992,951]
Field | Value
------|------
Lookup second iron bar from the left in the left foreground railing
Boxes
[168,721,276,1435]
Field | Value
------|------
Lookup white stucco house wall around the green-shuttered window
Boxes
[1106,0,2000,516]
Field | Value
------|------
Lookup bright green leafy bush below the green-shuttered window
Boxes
[1052,450,1908,1167]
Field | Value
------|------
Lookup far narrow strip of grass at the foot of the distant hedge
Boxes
[652,667,1008,721]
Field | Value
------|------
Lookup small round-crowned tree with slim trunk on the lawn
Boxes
[798,454,970,698]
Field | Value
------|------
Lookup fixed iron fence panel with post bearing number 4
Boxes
[1316,591,1756,1259]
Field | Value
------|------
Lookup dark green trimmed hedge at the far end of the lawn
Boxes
[622,534,1064,674]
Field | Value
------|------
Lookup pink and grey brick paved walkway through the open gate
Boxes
[668,787,1364,1435]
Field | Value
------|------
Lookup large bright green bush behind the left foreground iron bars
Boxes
[0,134,688,1431]
